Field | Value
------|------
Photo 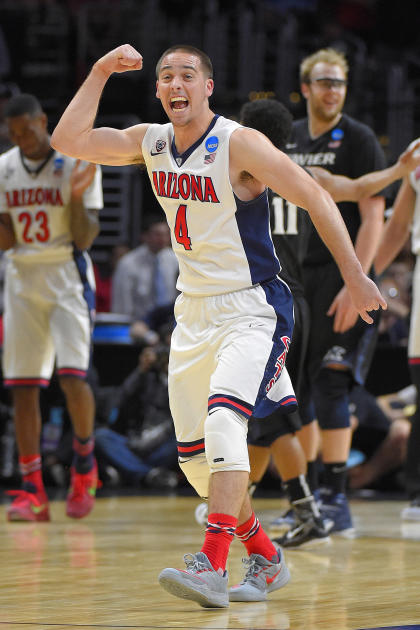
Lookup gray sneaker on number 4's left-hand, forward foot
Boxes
[158,551,229,608]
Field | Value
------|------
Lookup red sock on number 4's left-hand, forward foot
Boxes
[201,513,238,571]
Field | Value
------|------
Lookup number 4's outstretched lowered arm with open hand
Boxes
[230,129,386,323]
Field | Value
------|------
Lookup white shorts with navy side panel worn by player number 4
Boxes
[169,278,297,457]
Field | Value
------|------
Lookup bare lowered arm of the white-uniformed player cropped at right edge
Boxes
[375,177,416,273]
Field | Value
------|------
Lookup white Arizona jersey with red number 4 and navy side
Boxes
[142,116,280,296]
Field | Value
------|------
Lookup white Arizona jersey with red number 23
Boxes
[0,147,103,263]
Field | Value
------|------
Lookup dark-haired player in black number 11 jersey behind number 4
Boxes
[240,99,420,547]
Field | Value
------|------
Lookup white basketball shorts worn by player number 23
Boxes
[3,260,94,387]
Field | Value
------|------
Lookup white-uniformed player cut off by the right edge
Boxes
[375,139,420,521]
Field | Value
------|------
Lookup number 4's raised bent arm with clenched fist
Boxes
[51,44,148,166]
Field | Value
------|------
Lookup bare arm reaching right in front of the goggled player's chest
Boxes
[308,140,420,203]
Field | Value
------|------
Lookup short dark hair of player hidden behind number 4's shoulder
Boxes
[239,98,293,149]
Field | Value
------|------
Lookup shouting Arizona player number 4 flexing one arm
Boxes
[52,44,386,607]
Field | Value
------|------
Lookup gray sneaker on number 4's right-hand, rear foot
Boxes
[229,543,290,602]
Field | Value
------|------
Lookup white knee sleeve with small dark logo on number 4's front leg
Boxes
[204,407,250,473]
